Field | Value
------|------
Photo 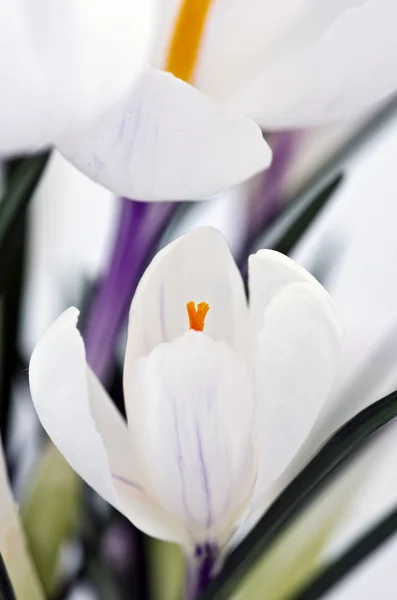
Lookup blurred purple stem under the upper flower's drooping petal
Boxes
[83,199,178,383]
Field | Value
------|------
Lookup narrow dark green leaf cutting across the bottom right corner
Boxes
[288,508,397,600]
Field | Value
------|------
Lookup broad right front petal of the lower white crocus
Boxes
[255,283,341,494]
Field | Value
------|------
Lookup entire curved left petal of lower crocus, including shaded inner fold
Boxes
[29,308,184,541]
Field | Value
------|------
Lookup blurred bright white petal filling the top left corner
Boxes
[0,0,154,154]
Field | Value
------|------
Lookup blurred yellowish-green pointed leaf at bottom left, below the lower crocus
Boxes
[22,442,80,595]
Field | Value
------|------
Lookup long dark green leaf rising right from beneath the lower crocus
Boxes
[200,392,397,600]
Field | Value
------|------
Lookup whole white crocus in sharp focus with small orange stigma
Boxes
[30,228,340,596]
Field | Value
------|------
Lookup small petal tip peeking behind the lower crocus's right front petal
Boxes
[248,250,322,331]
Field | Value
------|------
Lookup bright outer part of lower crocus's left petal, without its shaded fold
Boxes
[29,308,118,506]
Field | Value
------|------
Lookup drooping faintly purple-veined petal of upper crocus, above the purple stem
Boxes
[57,70,271,200]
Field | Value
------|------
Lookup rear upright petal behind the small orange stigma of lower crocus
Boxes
[125,227,249,382]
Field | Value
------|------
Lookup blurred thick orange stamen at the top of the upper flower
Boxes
[165,0,211,81]
